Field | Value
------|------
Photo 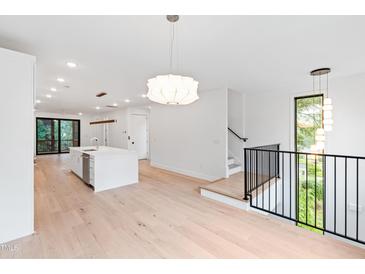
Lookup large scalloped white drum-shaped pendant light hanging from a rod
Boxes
[147,15,199,105]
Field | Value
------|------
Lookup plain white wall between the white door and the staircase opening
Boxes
[150,89,228,180]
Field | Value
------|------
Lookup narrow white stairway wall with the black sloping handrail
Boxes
[228,89,246,164]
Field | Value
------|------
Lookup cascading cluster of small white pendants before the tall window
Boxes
[310,68,333,151]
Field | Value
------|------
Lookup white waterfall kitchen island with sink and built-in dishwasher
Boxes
[70,146,138,192]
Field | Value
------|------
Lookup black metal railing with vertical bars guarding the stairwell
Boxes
[244,147,365,244]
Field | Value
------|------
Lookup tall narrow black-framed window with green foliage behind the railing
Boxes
[294,94,324,233]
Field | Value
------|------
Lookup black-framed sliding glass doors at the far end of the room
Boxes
[36,118,80,155]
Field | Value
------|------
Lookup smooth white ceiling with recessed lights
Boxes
[0,16,365,113]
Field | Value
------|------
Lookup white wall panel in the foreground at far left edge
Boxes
[0,48,35,243]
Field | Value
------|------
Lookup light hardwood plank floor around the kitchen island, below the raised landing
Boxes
[0,155,365,258]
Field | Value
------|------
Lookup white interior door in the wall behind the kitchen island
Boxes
[128,114,148,159]
